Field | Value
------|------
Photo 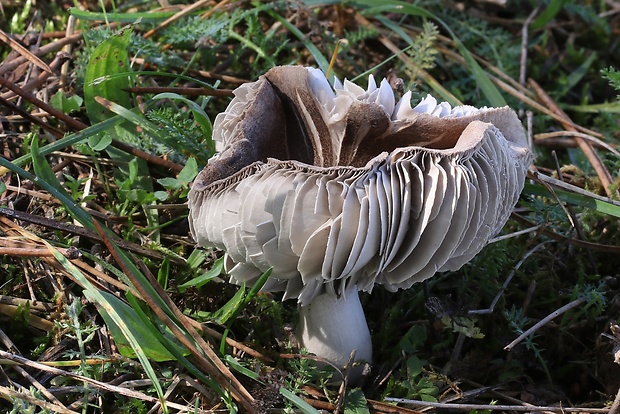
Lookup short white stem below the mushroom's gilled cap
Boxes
[297,288,372,367]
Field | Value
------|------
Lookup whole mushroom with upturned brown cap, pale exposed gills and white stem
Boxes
[189,66,532,376]
